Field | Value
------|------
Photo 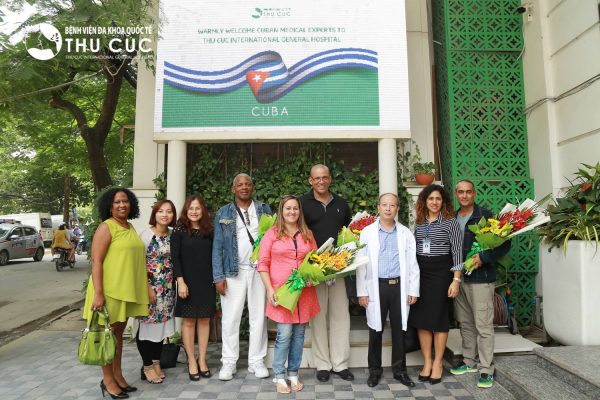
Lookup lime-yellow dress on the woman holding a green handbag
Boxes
[83,219,150,324]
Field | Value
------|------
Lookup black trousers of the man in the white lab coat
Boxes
[368,280,406,375]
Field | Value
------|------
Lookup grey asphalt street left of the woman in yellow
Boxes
[0,250,89,336]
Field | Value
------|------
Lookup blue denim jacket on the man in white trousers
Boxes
[212,200,272,282]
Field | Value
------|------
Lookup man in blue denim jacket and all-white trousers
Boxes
[212,174,271,381]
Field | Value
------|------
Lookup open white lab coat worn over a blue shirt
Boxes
[356,218,420,332]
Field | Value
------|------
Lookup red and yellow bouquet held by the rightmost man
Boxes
[464,196,550,275]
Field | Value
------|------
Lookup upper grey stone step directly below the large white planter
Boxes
[533,346,600,399]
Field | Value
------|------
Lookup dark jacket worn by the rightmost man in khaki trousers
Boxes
[456,204,510,283]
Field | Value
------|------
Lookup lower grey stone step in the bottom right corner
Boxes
[495,355,595,400]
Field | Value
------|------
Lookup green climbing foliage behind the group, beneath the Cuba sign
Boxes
[185,143,408,225]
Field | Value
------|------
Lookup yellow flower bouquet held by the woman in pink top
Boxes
[275,238,368,312]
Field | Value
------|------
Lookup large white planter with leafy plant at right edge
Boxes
[539,163,600,346]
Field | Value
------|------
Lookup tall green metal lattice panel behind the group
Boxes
[433,0,538,325]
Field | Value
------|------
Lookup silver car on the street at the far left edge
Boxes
[0,223,44,265]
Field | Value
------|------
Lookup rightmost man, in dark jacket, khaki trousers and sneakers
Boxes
[450,179,510,388]
